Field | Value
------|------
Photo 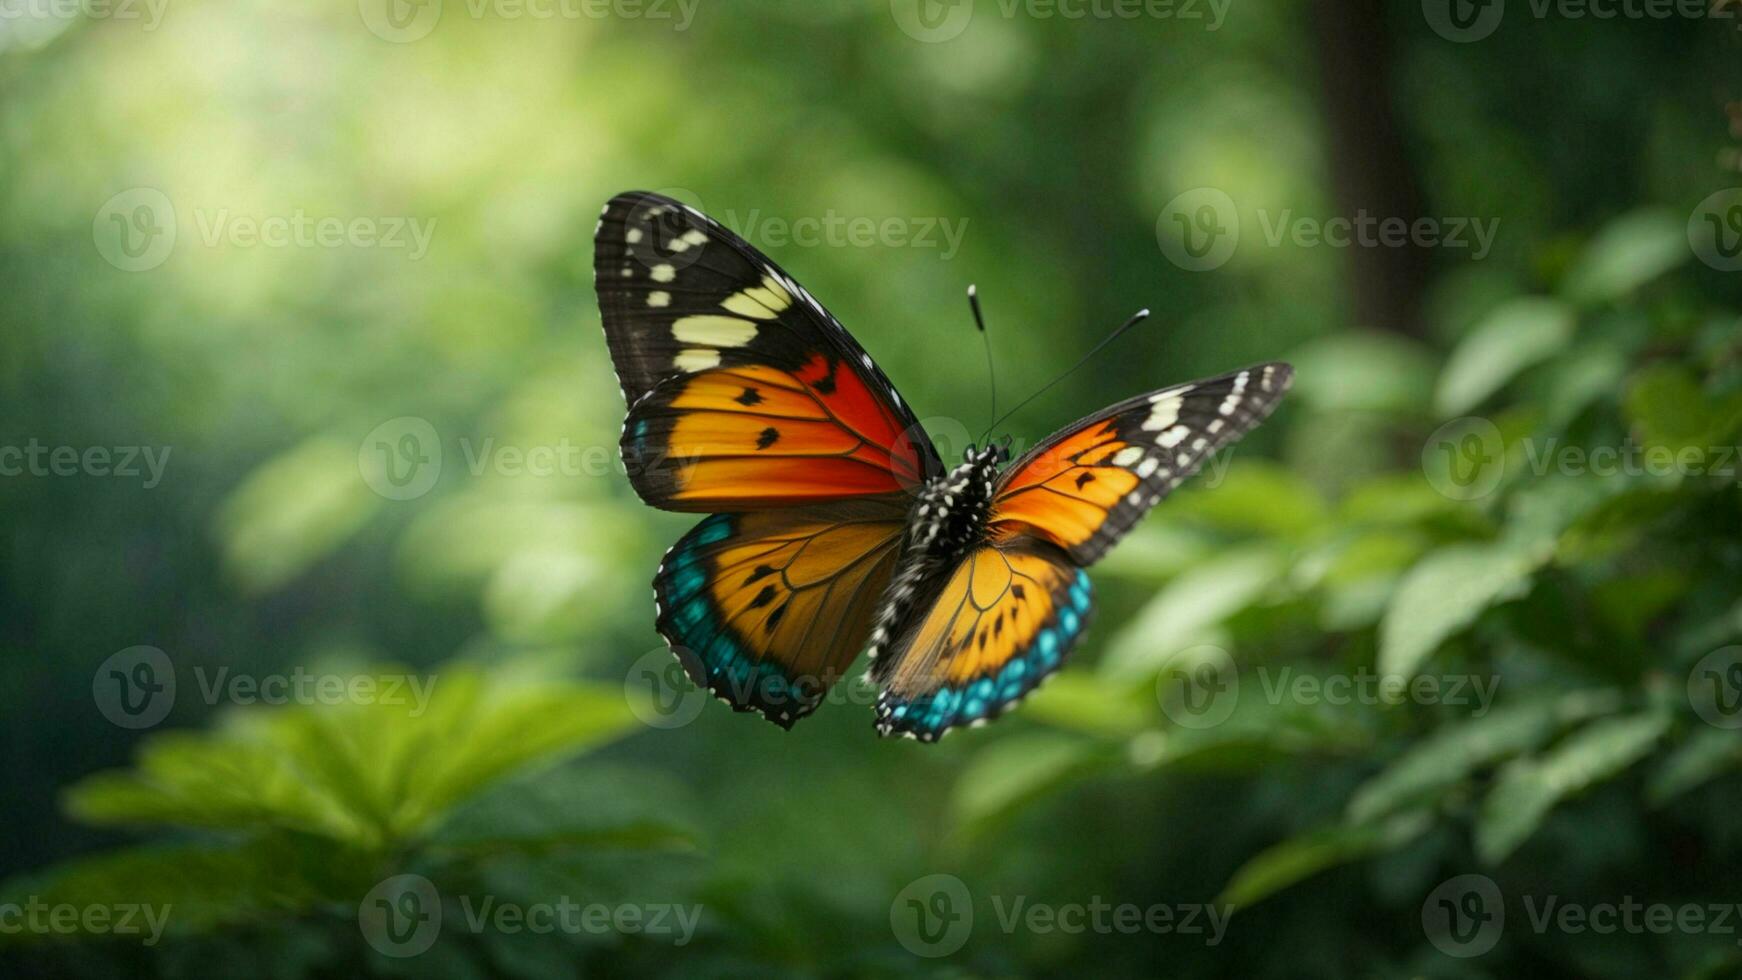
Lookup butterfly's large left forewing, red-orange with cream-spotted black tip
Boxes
[594,191,941,513]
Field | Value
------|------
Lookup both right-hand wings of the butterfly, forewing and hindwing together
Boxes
[873,364,1293,742]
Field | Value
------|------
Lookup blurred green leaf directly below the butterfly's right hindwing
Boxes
[949,733,1117,837]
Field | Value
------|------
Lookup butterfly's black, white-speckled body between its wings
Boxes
[866,446,1010,660]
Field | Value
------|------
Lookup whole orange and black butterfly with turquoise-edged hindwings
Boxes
[594,191,1293,742]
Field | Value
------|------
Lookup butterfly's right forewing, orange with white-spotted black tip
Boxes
[988,364,1294,566]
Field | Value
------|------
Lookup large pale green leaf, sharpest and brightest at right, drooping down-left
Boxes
[1378,543,1547,677]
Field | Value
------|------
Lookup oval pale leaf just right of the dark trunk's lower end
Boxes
[1434,298,1575,418]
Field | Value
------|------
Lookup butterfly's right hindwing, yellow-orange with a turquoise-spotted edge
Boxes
[873,540,1094,742]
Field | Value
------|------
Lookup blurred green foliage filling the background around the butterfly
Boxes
[10,0,1742,977]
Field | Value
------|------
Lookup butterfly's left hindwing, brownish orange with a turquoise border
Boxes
[653,496,906,728]
